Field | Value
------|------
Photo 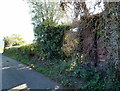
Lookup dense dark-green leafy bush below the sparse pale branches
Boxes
[34,21,68,59]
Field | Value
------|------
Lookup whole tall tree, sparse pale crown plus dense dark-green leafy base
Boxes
[28,0,68,59]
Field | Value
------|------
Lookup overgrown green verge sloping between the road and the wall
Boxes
[4,53,120,91]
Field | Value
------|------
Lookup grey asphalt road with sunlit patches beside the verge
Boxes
[0,56,61,90]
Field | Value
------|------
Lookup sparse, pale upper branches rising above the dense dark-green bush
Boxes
[27,0,64,27]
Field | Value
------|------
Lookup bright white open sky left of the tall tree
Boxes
[0,0,34,42]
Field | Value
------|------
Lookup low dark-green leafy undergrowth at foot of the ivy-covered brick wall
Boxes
[72,66,120,90]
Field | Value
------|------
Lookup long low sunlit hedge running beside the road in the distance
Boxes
[5,43,41,58]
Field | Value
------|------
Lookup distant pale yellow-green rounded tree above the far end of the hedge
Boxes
[4,34,26,47]
